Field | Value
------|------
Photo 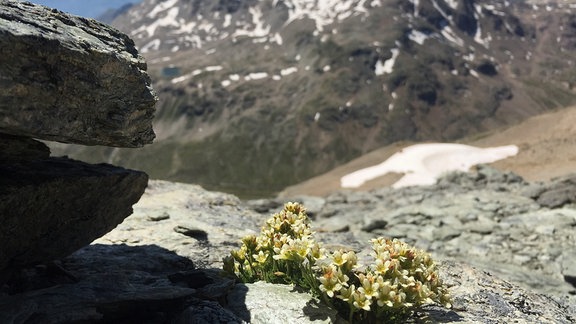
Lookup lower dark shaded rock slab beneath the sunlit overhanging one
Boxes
[0,158,148,273]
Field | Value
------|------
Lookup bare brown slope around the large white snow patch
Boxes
[279,106,576,196]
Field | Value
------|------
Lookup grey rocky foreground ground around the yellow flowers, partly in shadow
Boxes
[0,171,576,323]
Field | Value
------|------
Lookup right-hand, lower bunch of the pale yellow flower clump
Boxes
[319,237,451,321]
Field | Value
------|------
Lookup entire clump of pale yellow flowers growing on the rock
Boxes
[224,203,451,323]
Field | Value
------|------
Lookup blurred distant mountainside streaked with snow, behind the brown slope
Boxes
[50,0,576,196]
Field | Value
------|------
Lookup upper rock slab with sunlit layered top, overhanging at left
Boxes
[0,0,156,147]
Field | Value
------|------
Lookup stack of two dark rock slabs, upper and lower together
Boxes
[0,0,155,276]
